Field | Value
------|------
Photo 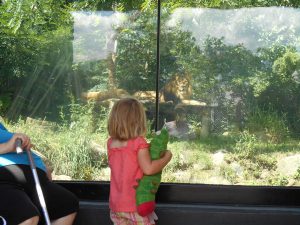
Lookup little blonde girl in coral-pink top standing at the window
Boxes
[107,98,172,225]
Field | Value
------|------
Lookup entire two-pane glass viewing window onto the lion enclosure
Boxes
[0,0,300,186]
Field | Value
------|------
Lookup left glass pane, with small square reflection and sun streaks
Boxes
[0,0,156,180]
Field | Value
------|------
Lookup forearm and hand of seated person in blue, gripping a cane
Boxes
[0,133,32,154]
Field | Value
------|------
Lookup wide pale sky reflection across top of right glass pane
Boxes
[166,7,300,52]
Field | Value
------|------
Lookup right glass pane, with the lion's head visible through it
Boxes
[160,3,300,186]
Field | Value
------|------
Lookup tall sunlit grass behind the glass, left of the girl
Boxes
[10,104,107,180]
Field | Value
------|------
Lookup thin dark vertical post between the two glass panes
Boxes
[155,0,161,131]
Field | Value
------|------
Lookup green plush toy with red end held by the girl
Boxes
[136,128,169,216]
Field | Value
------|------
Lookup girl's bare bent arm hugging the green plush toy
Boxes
[138,148,172,175]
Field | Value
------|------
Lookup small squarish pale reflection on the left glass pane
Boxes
[72,11,126,63]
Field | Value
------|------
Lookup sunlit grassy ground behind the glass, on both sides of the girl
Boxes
[5,104,300,185]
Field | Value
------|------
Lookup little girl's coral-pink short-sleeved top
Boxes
[107,137,149,212]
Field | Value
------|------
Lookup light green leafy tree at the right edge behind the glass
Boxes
[257,48,300,134]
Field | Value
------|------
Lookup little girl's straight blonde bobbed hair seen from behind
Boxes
[108,98,147,141]
